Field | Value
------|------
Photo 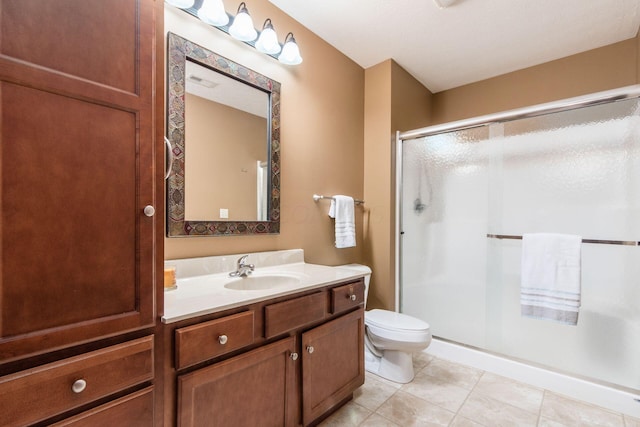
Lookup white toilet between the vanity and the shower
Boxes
[338,264,431,384]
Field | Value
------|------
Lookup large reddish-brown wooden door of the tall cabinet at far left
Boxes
[0,0,161,361]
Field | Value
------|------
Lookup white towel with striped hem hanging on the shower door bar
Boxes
[520,233,582,325]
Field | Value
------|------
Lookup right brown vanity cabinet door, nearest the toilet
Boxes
[302,309,364,425]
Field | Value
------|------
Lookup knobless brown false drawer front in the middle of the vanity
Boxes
[264,292,327,338]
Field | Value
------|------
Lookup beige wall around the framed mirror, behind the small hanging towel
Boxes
[165,0,364,265]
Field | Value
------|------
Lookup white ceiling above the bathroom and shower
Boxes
[270,0,640,93]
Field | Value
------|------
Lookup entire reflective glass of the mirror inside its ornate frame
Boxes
[184,60,269,221]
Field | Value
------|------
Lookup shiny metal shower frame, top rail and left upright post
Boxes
[395,85,640,312]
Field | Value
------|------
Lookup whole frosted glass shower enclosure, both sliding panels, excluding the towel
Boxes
[398,87,640,406]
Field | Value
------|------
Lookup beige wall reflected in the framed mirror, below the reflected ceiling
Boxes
[184,93,267,221]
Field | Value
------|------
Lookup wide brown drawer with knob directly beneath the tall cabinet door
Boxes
[0,336,153,425]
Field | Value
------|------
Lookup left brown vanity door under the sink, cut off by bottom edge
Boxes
[178,337,299,427]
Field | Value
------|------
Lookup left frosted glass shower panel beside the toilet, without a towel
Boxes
[401,127,492,345]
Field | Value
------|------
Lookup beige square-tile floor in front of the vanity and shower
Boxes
[320,353,640,427]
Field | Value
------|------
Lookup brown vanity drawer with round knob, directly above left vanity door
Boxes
[176,311,254,369]
